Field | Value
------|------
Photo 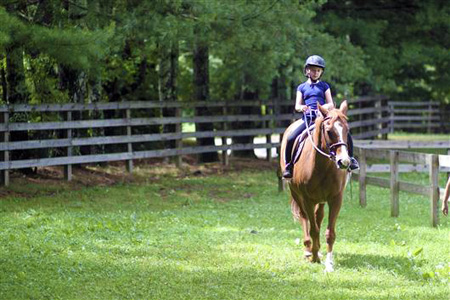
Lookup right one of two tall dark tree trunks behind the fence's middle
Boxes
[194,41,219,162]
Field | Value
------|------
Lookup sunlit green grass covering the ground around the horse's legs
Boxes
[0,165,450,299]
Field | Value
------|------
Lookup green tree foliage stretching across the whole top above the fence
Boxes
[0,0,450,102]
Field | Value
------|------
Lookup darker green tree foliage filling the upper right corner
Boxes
[318,0,450,103]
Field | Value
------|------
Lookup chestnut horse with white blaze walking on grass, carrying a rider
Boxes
[280,101,350,271]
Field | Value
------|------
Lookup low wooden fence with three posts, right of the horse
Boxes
[353,143,450,226]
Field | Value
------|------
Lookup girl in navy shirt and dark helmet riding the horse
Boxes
[283,55,359,178]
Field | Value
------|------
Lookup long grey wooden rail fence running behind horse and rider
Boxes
[0,97,448,185]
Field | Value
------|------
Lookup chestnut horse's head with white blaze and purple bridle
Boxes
[316,101,350,169]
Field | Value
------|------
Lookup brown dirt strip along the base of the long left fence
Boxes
[0,158,277,198]
